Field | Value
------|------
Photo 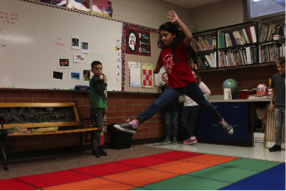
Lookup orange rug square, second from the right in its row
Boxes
[148,161,212,174]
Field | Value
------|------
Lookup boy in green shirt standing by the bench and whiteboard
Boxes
[89,61,107,158]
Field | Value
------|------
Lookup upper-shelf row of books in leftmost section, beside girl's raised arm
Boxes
[191,36,216,52]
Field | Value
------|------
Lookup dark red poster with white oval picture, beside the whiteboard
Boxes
[125,28,151,56]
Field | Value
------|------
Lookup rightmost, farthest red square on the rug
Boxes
[149,151,202,160]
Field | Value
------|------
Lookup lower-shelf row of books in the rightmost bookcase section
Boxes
[260,43,286,63]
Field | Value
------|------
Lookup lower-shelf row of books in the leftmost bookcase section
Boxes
[191,52,217,70]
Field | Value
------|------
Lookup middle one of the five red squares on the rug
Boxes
[71,162,137,176]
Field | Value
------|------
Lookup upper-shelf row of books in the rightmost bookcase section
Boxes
[259,23,283,42]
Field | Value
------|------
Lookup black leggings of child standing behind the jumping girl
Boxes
[180,106,201,137]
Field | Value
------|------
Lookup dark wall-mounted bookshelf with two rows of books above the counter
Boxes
[191,15,286,72]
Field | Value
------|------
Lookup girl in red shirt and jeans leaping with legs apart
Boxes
[114,11,233,135]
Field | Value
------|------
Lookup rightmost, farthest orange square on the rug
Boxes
[181,154,239,165]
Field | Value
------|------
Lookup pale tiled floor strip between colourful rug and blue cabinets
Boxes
[143,142,286,162]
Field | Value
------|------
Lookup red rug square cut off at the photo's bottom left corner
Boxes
[0,178,36,191]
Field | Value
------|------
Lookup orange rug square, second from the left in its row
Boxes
[103,169,178,186]
